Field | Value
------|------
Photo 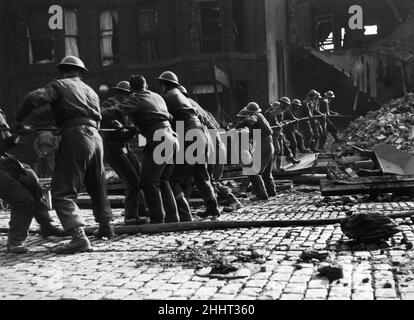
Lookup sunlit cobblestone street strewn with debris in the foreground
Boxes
[0,189,414,300]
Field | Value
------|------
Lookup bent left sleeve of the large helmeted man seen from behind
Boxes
[16,82,58,123]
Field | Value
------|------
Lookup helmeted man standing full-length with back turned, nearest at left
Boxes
[16,56,114,253]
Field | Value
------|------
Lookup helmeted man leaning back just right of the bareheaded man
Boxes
[158,71,220,221]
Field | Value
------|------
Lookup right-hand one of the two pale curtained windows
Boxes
[100,10,119,66]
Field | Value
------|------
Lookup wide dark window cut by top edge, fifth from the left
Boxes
[190,0,221,53]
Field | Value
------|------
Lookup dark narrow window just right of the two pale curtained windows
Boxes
[138,8,158,61]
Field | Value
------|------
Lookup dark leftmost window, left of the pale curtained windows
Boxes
[26,8,55,64]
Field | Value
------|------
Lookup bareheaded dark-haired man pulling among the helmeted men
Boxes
[102,75,180,224]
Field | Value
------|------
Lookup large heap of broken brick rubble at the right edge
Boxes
[344,93,414,154]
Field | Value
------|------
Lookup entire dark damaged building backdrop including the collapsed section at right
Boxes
[0,0,413,162]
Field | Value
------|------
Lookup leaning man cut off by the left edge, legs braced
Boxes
[0,109,65,254]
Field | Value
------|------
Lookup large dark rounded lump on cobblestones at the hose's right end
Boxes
[341,213,400,243]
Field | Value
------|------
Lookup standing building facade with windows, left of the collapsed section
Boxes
[0,0,287,164]
